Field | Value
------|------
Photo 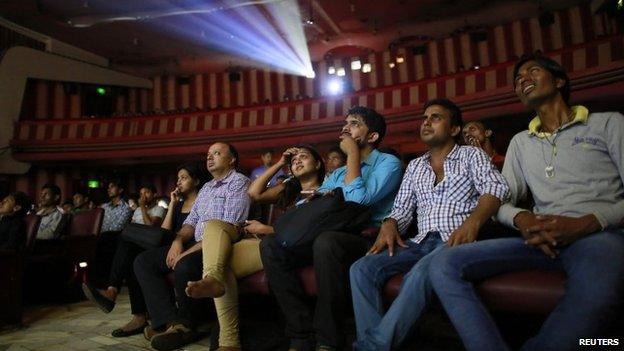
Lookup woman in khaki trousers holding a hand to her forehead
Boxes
[186,146,325,351]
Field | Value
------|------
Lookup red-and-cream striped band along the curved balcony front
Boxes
[14,35,624,145]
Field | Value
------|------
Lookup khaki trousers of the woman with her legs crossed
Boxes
[202,220,262,347]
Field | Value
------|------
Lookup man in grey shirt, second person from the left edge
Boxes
[37,183,63,240]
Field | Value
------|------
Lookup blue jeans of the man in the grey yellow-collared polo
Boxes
[429,230,624,351]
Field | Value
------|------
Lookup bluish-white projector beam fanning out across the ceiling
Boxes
[79,0,315,78]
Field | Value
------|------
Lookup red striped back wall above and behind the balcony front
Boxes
[19,4,617,119]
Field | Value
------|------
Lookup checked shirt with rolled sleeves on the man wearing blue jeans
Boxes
[388,145,509,243]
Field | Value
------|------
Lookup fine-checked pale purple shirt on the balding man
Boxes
[184,171,251,242]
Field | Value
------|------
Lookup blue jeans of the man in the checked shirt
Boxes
[350,232,444,351]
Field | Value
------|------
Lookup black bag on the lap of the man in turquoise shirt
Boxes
[273,188,371,248]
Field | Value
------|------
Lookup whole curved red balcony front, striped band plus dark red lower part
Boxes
[11,35,624,170]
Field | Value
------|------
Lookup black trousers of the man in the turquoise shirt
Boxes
[260,232,371,348]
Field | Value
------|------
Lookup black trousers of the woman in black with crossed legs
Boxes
[108,237,147,314]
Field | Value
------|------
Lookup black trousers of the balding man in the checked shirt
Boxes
[134,246,212,329]
